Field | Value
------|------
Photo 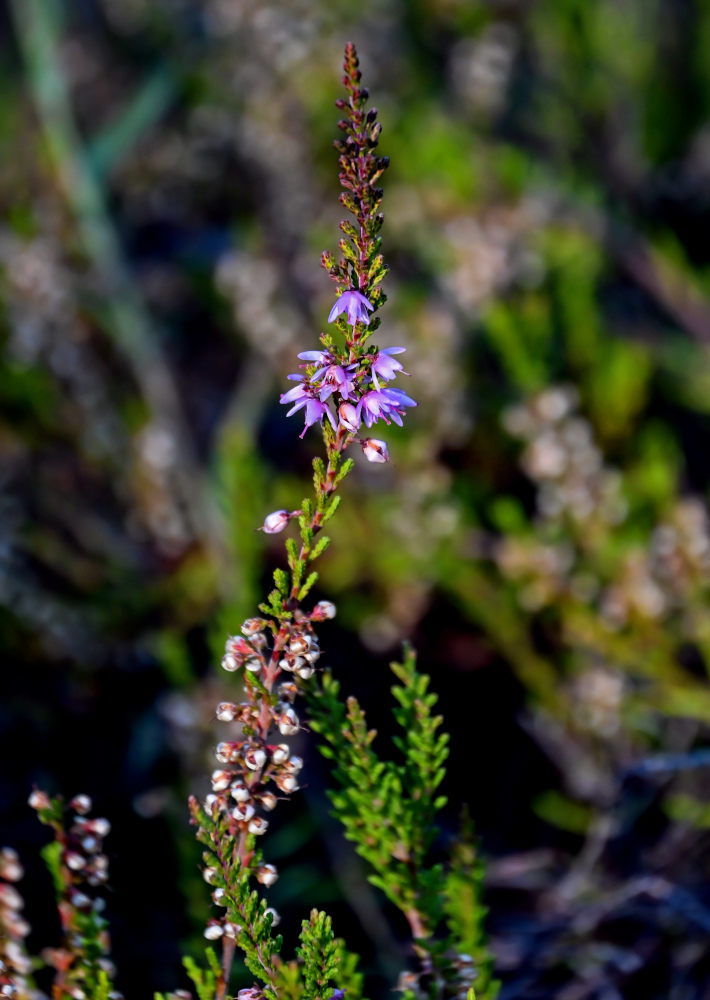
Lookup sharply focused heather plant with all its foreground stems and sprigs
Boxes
[0,44,497,1000]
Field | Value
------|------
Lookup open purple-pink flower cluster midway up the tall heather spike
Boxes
[281,289,417,446]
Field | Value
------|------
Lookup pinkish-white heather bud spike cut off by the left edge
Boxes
[0,847,31,998]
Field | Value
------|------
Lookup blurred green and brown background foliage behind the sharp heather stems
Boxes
[0,0,710,1000]
